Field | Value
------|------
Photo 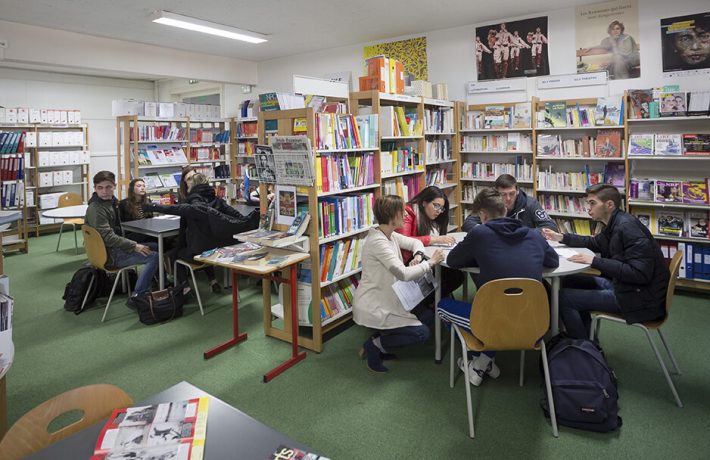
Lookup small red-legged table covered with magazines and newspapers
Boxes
[195,248,310,382]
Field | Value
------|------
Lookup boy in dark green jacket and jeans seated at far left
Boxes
[86,171,158,306]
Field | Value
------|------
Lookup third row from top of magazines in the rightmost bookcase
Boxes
[629,177,710,204]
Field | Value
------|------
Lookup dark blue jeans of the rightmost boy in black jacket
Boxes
[560,275,621,339]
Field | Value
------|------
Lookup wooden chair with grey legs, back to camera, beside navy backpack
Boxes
[449,278,558,438]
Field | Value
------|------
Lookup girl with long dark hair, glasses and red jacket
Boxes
[395,185,463,303]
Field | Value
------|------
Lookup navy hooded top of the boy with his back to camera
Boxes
[446,217,560,286]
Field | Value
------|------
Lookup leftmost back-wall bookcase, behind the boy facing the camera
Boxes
[458,99,535,223]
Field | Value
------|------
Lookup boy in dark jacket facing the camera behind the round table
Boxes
[462,174,558,233]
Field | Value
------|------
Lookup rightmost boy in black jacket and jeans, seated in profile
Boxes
[543,184,670,339]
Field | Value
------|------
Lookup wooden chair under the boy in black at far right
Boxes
[589,251,683,407]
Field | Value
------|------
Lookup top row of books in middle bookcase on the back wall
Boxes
[537,96,624,128]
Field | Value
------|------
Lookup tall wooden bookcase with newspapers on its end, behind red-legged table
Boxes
[258,108,380,352]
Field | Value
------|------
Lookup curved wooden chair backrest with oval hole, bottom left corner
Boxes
[0,384,133,460]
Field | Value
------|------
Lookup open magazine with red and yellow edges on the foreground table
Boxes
[91,397,209,460]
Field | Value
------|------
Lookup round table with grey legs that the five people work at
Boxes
[424,237,594,363]
